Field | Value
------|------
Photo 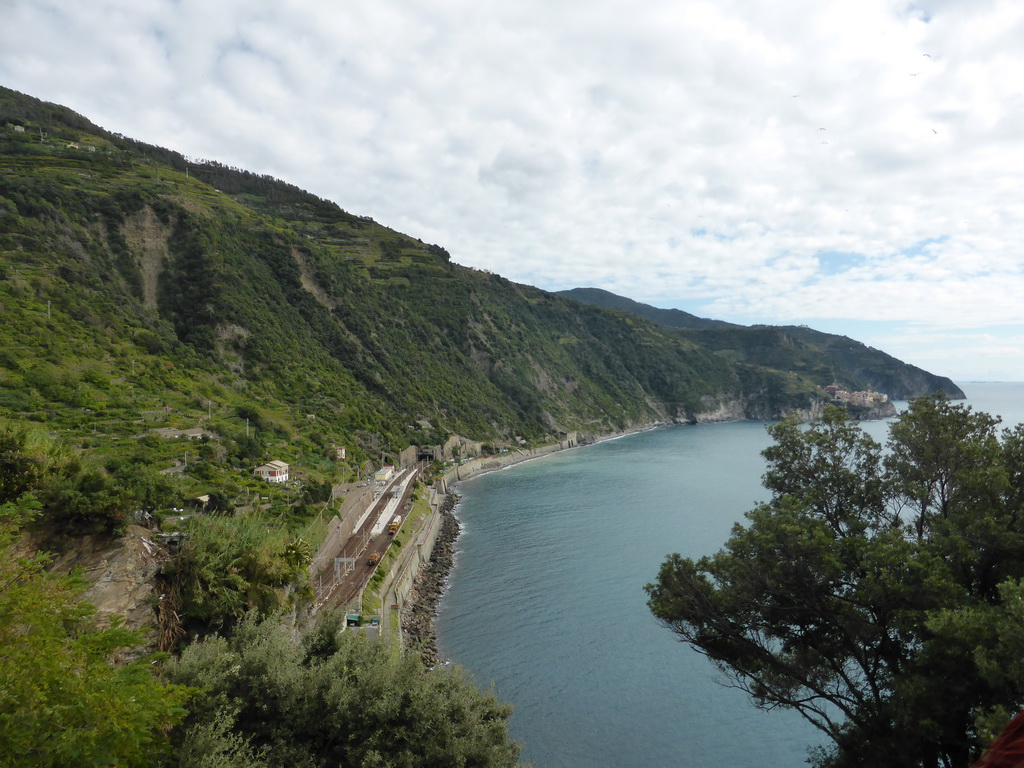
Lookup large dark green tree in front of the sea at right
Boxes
[647,397,1024,768]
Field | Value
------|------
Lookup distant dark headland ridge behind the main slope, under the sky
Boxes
[558,288,965,400]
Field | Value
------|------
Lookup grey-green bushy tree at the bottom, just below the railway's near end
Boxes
[168,614,519,768]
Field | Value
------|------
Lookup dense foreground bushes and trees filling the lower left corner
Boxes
[0,428,518,768]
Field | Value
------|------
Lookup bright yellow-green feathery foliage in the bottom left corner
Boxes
[0,495,187,768]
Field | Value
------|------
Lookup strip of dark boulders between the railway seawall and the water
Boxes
[401,492,460,667]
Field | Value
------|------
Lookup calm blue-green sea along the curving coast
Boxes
[436,383,1024,768]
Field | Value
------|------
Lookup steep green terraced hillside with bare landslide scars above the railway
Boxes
[0,89,948,505]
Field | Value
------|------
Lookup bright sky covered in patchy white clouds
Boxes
[0,0,1024,385]
